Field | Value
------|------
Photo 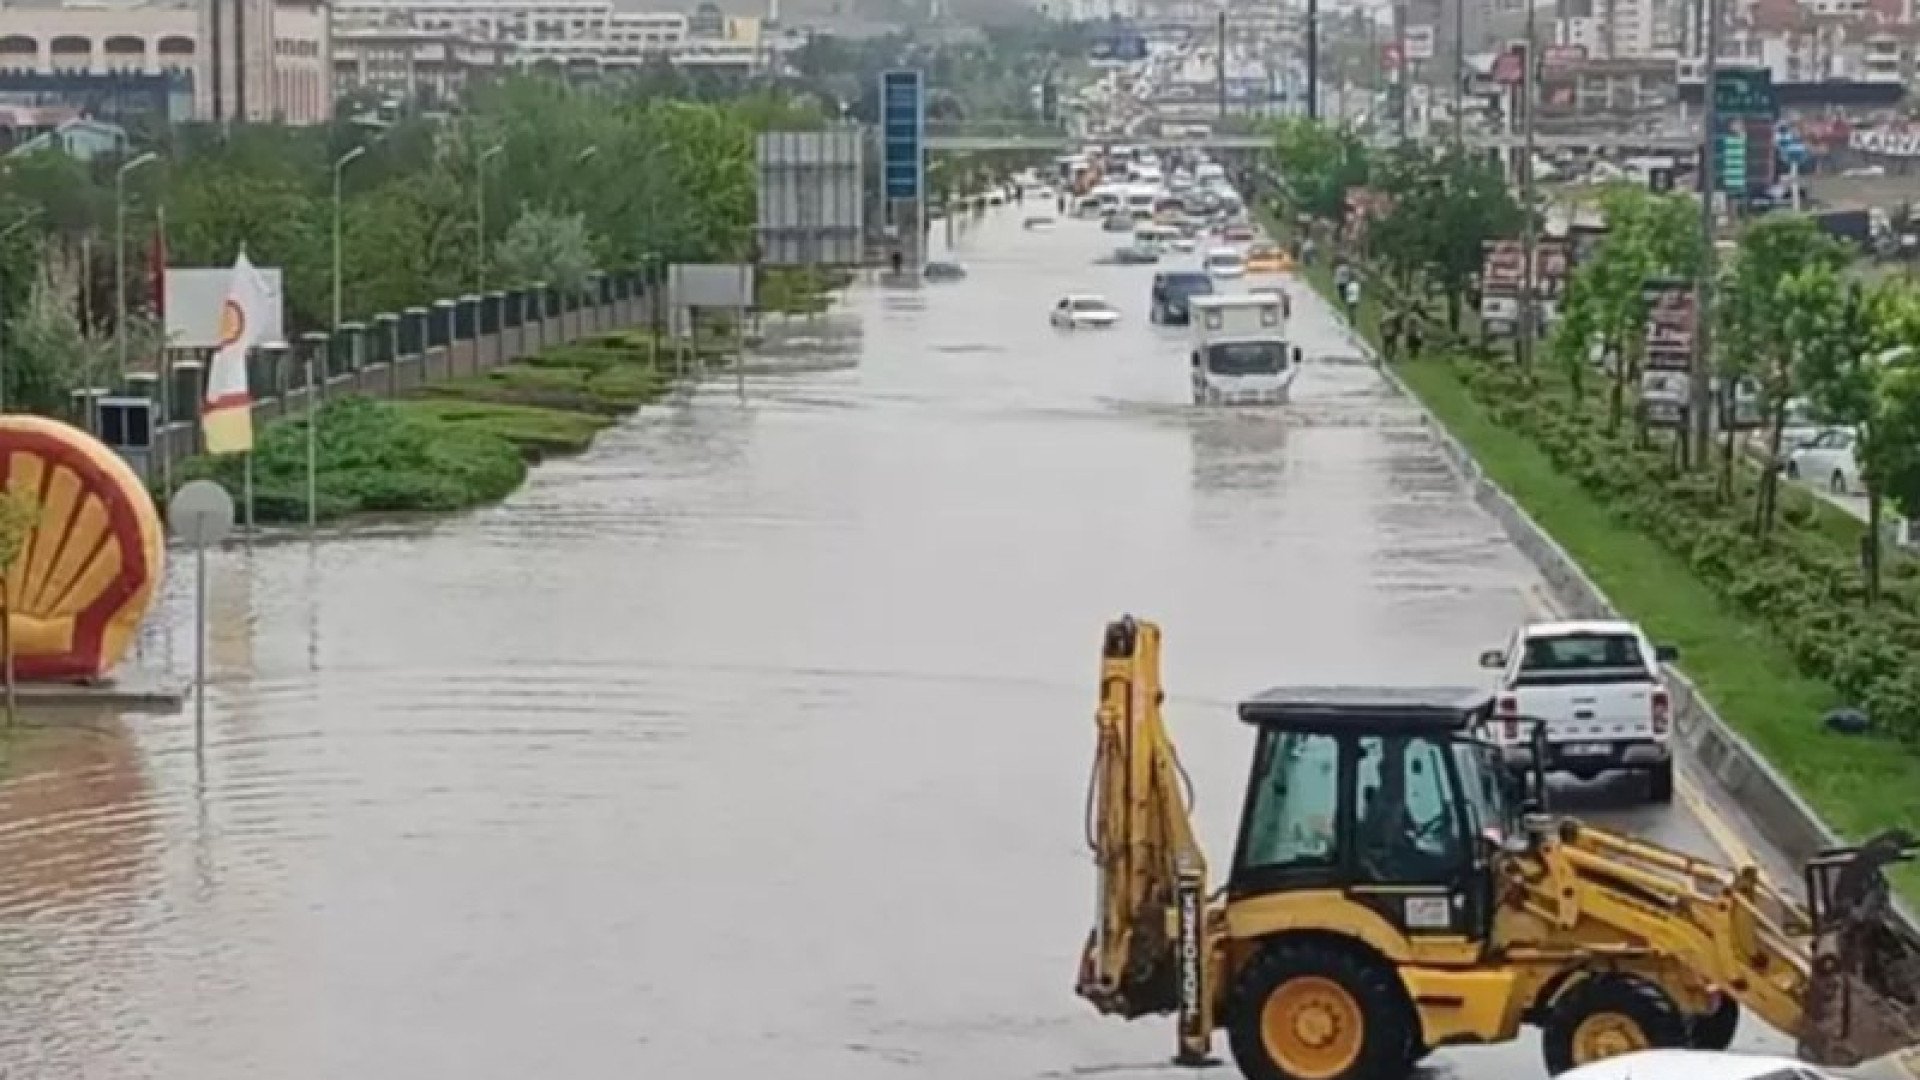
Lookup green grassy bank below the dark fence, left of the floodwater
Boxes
[168,331,670,523]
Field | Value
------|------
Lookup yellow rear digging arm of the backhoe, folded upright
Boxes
[1075,615,1213,1063]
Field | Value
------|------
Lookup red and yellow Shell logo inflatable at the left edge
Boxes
[0,413,165,682]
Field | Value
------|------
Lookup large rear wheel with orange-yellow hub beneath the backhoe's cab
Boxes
[1227,940,1419,1080]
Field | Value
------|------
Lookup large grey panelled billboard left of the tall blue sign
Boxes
[755,127,866,267]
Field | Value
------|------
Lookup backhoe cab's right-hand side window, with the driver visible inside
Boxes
[1354,736,1467,884]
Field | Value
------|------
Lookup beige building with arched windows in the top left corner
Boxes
[0,0,332,125]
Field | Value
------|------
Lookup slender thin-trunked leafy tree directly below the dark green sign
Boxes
[1715,213,1847,536]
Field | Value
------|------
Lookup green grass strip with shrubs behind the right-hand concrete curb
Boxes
[1308,259,1920,899]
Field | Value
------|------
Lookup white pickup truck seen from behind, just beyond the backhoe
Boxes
[1480,621,1680,803]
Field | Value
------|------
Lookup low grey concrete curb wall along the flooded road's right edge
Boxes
[1359,340,1920,930]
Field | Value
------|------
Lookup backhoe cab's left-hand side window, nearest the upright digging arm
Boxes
[1242,734,1340,871]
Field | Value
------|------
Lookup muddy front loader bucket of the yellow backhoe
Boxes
[1799,830,1920,1068]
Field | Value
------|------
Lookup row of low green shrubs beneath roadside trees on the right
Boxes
[1453,359,1920,746]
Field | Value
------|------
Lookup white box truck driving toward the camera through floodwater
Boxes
[1187,292,1300,405]
